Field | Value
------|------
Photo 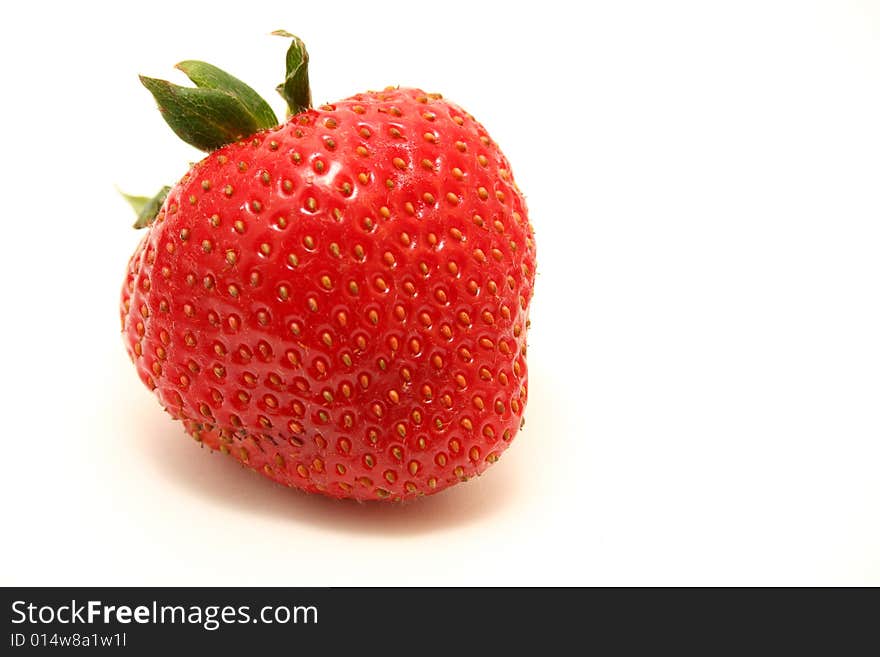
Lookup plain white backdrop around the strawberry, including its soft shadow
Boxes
[0,0,880,585]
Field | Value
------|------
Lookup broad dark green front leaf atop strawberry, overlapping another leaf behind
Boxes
[140,75,261,151]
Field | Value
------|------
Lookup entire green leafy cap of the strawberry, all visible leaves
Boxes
[122,30,312,228]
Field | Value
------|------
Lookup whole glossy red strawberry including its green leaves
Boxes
[121,33,535,500]
